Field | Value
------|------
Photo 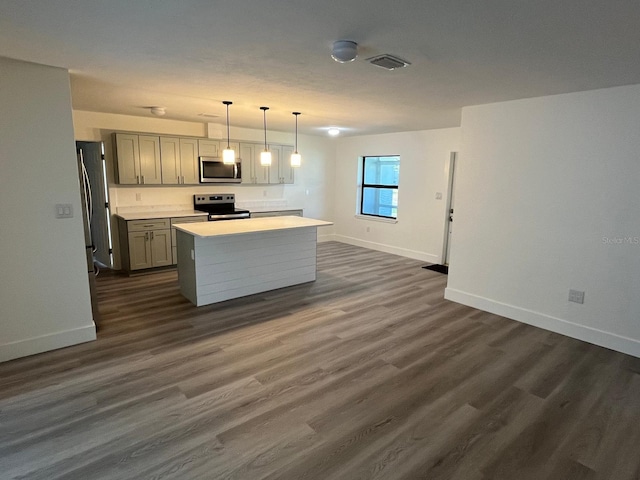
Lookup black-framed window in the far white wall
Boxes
[360,155,400,219]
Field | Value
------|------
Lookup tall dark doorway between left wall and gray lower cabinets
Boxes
[76,142,113,268]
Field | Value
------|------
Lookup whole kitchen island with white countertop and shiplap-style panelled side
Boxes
[175,216,332,306]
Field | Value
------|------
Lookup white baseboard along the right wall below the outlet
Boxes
[444,288,640,357]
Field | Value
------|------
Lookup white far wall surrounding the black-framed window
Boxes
[334,128,460,263]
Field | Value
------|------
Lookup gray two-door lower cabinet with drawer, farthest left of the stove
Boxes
[119,218,173,271]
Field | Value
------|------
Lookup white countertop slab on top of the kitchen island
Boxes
[174,216,333,238]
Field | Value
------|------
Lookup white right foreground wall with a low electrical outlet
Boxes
[446,85,640,356]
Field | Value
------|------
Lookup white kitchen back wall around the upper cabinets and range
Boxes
[73,111,335,268]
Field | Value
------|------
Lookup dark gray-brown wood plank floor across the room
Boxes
[0,242,640,480]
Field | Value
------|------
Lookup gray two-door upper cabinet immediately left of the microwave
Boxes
[160,137,199,185]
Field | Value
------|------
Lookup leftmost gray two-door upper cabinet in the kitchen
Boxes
[115,133,162,185]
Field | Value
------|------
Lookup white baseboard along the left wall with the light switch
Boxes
[0,322,96,362]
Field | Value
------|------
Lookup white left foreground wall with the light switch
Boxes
[0,57,96,361]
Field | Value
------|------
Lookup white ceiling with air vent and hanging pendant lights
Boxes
[0,0,640,135]
